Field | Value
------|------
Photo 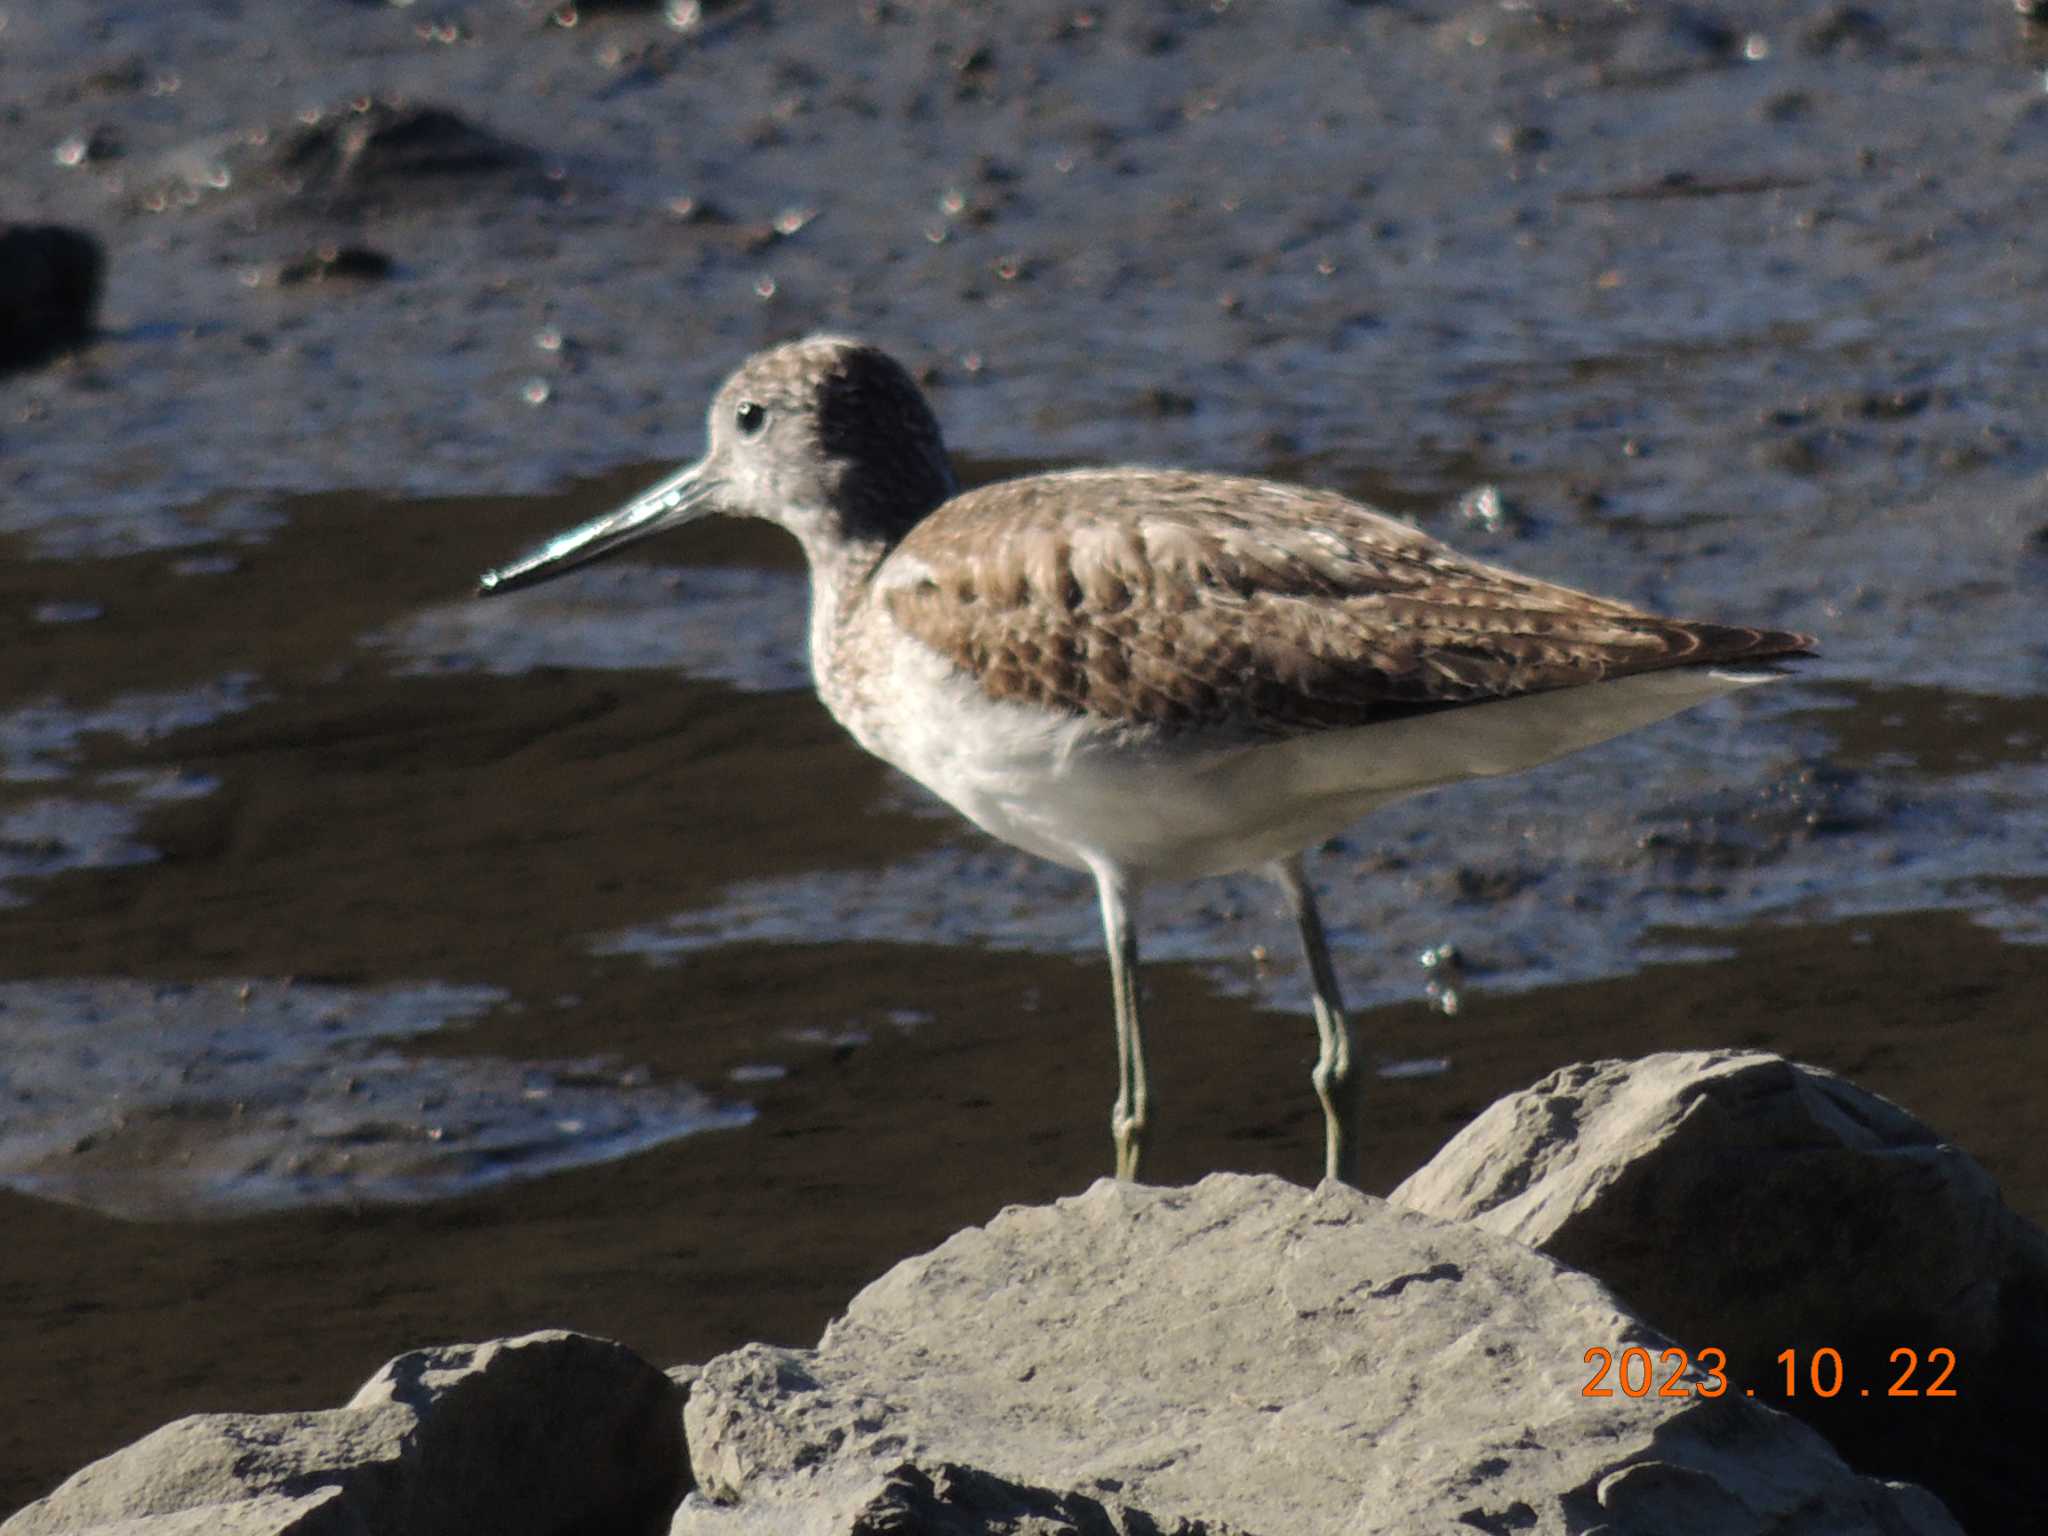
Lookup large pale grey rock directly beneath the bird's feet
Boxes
[674,1174,1956,1536]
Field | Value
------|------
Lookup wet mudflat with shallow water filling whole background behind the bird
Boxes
[0,0,2048,1507]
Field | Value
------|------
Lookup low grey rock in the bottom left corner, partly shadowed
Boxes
[0,1333,682,1536]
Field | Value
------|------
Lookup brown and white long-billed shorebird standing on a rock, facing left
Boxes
[481,336,1812,1182]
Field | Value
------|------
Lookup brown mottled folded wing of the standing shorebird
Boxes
[877,469,1812,735]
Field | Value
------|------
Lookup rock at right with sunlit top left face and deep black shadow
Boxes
[1393,1051,2048,1530]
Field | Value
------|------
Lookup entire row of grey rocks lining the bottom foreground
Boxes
[12,1053,2048,1536]
